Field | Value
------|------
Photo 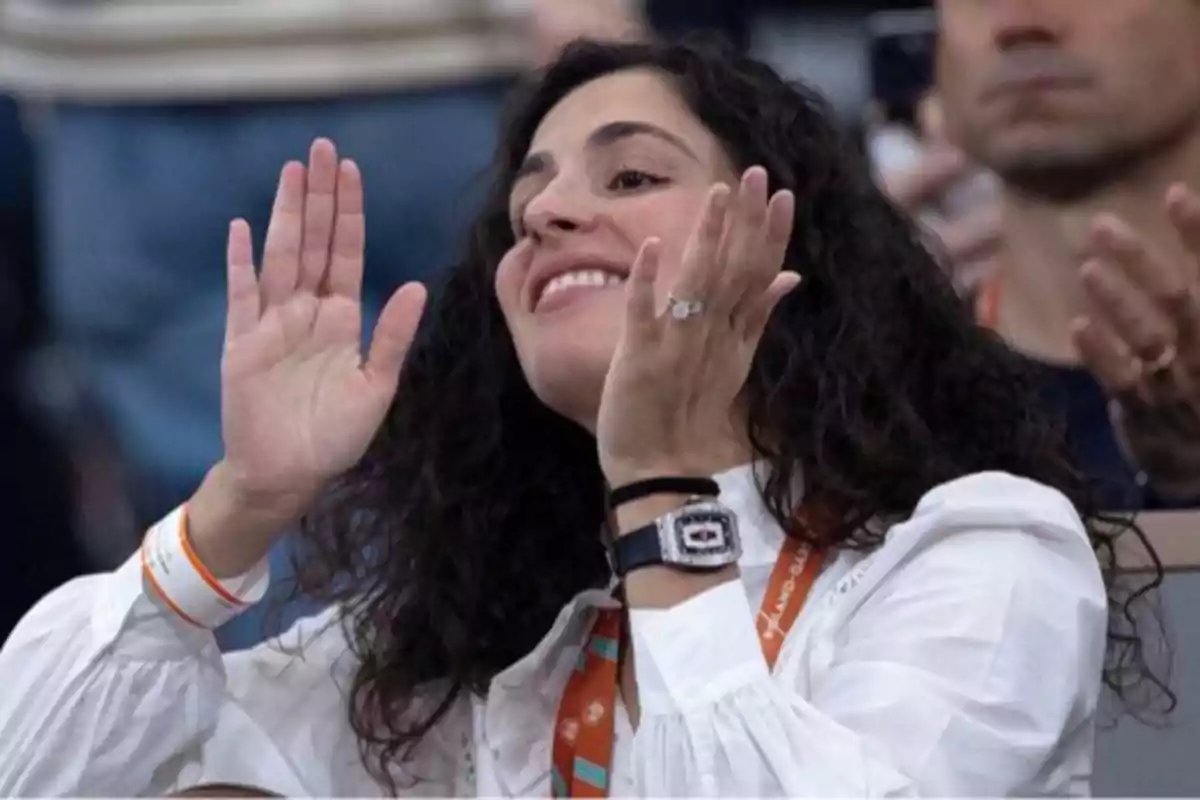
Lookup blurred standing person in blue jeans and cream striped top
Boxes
[0,0,637,642]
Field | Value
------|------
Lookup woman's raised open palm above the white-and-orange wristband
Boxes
[221,139,425,494]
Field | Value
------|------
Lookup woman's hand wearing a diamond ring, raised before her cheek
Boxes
[596,167,800,487]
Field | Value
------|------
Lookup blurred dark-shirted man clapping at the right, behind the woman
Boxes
[887,0,1200,507]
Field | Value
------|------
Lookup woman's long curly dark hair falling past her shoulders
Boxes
[290,35,1174,788]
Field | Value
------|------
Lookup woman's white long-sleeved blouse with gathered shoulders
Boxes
[0,467,1106,796]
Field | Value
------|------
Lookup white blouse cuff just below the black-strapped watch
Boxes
[629,581,769,715]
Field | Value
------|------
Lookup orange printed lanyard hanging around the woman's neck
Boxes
[551,509,824,798]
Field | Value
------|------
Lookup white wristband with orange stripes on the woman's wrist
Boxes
[142,506,270,630]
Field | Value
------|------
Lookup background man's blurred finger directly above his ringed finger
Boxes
[1080,258,1175,361]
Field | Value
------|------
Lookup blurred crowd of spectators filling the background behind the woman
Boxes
[0,0,1200,657]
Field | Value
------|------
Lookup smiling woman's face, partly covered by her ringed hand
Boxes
[496,70,738,429]
